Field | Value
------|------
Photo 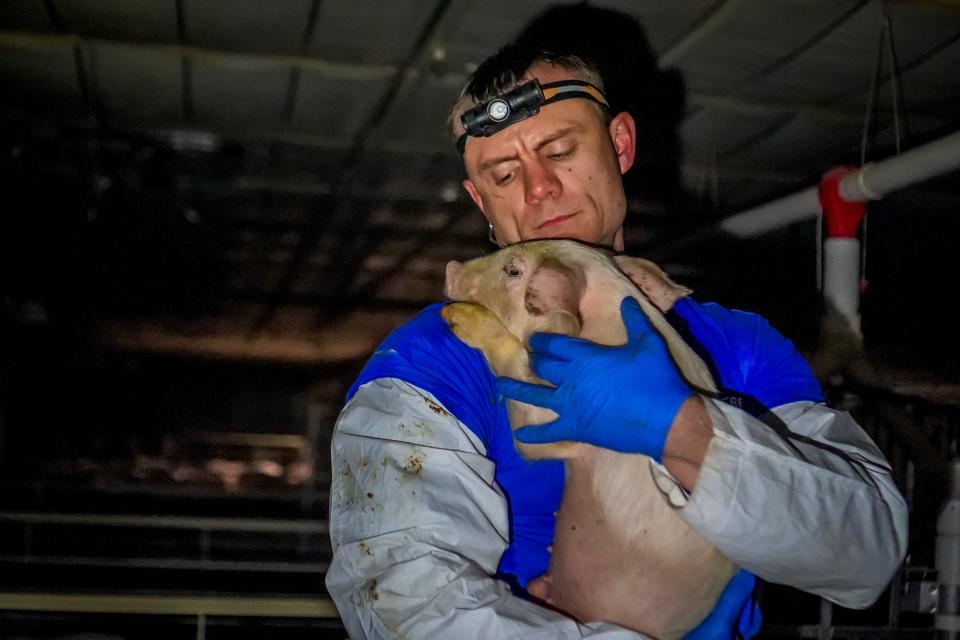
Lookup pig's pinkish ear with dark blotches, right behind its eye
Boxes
[524,262,585,336]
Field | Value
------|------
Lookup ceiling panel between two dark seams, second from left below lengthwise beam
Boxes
[91,45,183,124]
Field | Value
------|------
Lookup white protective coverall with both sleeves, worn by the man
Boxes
[327,302,907,640]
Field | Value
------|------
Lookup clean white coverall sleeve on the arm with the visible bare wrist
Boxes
[658,399,907,608]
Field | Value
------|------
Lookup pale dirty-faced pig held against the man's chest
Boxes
[441,240,736,639]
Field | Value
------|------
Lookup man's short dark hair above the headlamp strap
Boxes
[447,43,603,141]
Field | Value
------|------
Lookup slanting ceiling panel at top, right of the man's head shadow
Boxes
[678,0,862,94]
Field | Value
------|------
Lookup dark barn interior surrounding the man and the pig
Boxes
[0,0,960,639]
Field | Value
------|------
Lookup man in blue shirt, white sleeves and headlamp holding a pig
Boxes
[327,48,906,638]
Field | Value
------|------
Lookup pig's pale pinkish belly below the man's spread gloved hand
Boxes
[549,447,735,639]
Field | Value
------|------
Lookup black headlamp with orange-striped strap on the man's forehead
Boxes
[457,80,610,155]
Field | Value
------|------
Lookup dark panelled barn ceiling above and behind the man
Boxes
[0,0,960,376]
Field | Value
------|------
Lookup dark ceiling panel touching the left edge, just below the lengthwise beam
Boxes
[0,47,87,117]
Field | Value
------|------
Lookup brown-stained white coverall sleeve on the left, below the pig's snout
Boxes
[326,378,644,640]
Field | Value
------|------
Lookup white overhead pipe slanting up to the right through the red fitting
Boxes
[720,131,960,238]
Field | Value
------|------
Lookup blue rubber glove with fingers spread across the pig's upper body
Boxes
[497,297,693,462]
